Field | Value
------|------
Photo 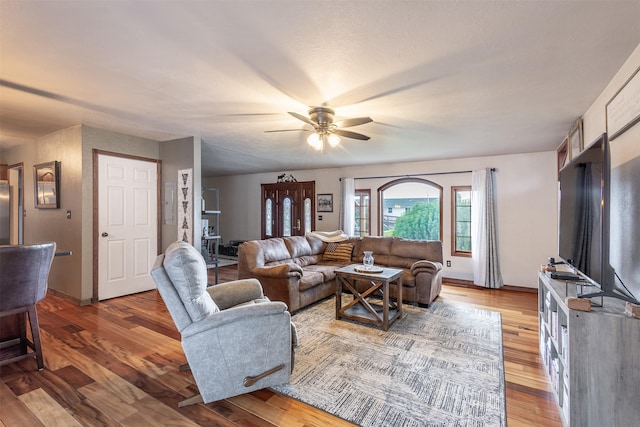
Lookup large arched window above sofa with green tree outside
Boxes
[378,177,442,240]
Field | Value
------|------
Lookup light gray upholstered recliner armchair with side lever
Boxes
[151,241,297,406]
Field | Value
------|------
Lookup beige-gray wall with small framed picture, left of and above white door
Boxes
[3,125,165,303]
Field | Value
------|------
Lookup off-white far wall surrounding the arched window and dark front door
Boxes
[203,152,557,288]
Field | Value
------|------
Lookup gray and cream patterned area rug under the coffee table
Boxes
[273,297,506,427]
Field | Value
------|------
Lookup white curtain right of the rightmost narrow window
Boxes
[471,169,503,288]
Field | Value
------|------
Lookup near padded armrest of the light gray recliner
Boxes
[181,301,289,339]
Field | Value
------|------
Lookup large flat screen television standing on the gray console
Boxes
[558,133,637,302]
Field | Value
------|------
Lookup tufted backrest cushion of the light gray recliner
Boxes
[163,241,220,322]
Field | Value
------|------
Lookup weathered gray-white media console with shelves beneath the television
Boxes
[538,273,640,427]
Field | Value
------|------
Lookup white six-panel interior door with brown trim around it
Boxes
[97,154,158,300]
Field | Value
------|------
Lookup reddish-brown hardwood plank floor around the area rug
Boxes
[0,266,561,427]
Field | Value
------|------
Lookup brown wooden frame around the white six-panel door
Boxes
[91,148,162,304]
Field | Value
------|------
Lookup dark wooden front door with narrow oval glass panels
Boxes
[262,181,316,239]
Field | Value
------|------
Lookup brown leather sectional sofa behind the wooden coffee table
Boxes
[238,236,442,312]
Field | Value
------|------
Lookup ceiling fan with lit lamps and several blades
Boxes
[266,106,373,151]
